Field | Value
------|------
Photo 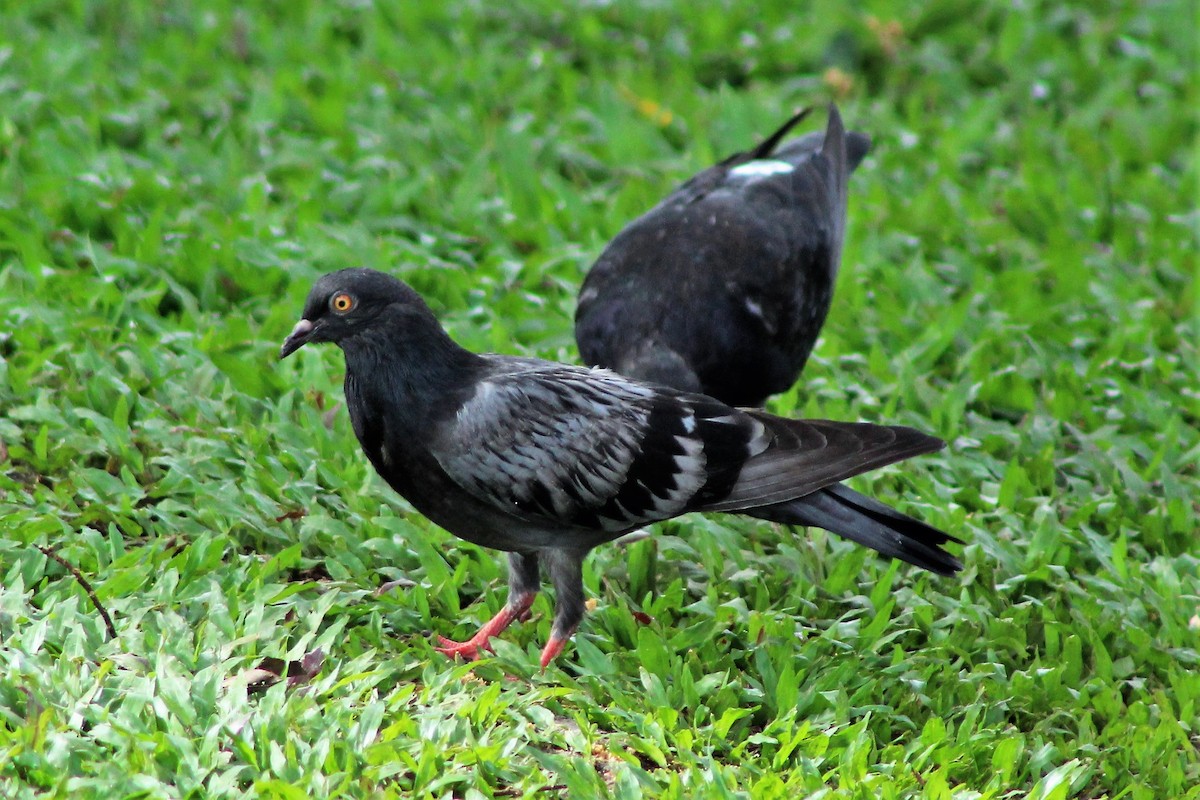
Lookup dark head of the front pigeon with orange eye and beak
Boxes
[280,269,436,359]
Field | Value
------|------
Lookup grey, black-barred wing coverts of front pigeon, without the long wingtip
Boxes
[432,360,761,534]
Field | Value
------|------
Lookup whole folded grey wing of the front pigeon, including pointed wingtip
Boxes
[431,360,943,535]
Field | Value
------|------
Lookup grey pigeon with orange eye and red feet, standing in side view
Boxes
[280,269,959,669]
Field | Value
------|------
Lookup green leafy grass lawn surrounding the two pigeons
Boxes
[0,0,1200,800]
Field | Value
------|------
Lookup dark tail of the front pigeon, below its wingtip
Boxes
[742,483,962,575]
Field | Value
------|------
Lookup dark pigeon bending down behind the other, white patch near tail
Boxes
[575,107,870,405]
